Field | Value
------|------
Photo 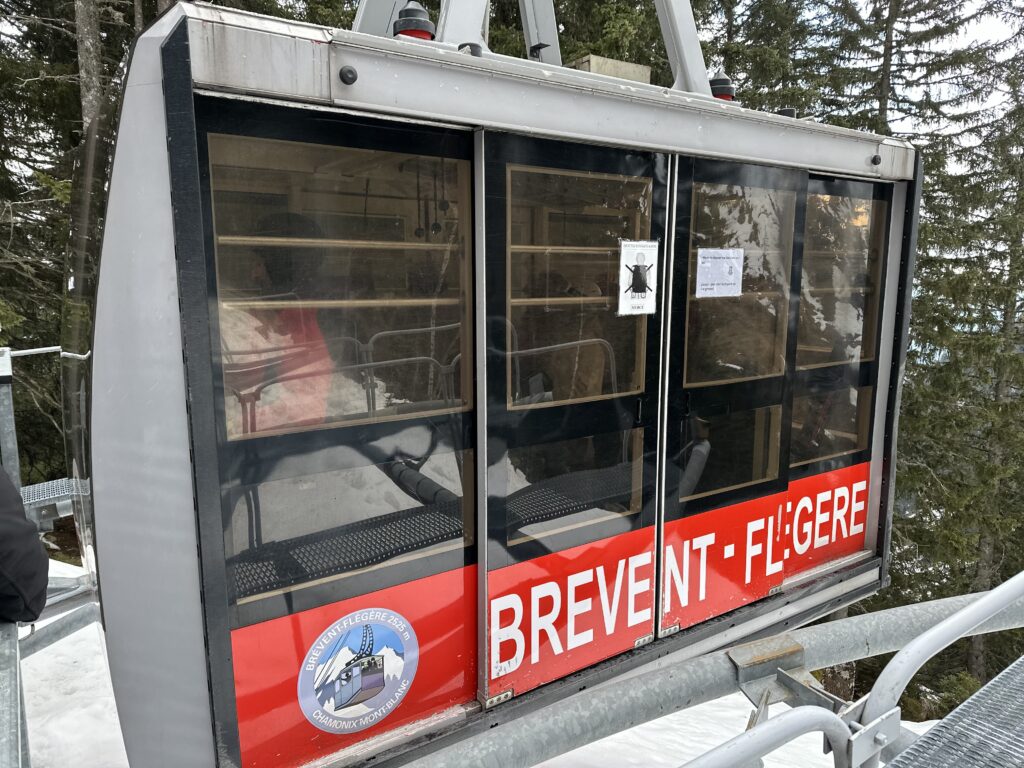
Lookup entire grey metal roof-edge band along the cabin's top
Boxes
[174,4,913,179]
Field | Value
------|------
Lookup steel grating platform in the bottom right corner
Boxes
[888,656,1024,768]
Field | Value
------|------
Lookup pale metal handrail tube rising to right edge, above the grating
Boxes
[860,571,1024,724]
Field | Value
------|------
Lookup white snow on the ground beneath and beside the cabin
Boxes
[22,561,931,768]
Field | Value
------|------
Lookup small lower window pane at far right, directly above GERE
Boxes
[790,387,873,466]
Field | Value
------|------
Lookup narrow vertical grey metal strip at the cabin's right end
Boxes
[864,183,907,550]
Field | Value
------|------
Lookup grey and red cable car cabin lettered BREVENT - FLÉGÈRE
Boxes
[83,2,919,768]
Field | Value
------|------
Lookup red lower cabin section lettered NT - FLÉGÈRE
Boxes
[662,463,869,628]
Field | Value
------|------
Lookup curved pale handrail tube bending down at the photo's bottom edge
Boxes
[684,707,852,768]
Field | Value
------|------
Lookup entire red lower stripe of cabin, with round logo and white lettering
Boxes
[231,464,868,768]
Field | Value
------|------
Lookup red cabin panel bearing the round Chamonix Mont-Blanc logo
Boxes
[231,566,476,768]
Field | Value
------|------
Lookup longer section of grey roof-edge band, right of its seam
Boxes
[321,37,913,178]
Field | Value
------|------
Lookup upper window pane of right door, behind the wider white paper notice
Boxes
[684,183,797,387]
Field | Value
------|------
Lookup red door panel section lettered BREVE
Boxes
[487,527,654,696]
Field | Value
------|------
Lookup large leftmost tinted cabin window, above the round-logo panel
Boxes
[207,134,473,621]
